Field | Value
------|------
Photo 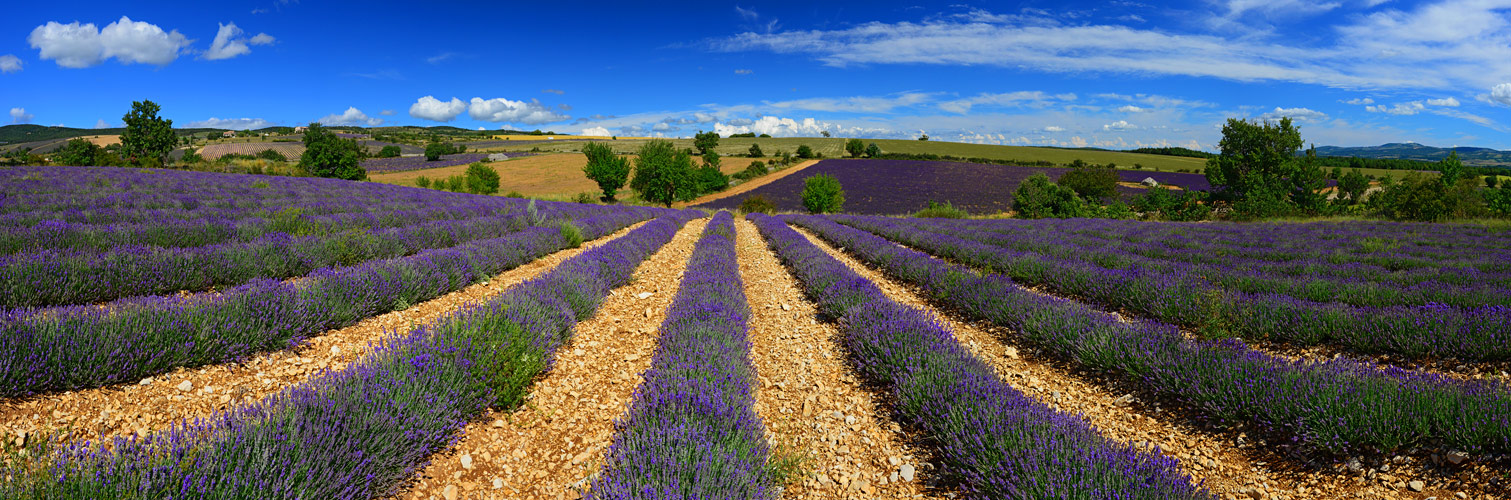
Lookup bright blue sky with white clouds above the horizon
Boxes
[0,0,1511,150]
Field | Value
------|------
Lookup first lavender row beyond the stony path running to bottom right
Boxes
[787,216,1511,453]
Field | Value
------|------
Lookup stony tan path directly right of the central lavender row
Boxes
[734,219,929,498]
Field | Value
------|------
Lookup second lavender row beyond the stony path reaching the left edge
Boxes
[0,204,583,308]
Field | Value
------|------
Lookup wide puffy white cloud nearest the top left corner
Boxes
[26,15,192,68]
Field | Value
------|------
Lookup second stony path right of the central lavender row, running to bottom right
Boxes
[795,228,1493,500]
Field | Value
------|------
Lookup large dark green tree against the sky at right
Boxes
[1206,118,1301,218]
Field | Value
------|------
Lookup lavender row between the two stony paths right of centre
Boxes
[749,215,1212,498]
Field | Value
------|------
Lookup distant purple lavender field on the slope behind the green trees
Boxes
[698,160,1212,215]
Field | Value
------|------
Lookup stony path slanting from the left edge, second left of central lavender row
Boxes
[0,222,644,450]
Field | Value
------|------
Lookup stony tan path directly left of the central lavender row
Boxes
[399,219,709,500]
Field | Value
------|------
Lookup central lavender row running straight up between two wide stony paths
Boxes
[591,211,774,498]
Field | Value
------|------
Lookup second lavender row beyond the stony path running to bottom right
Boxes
[834,216,1511,360]
